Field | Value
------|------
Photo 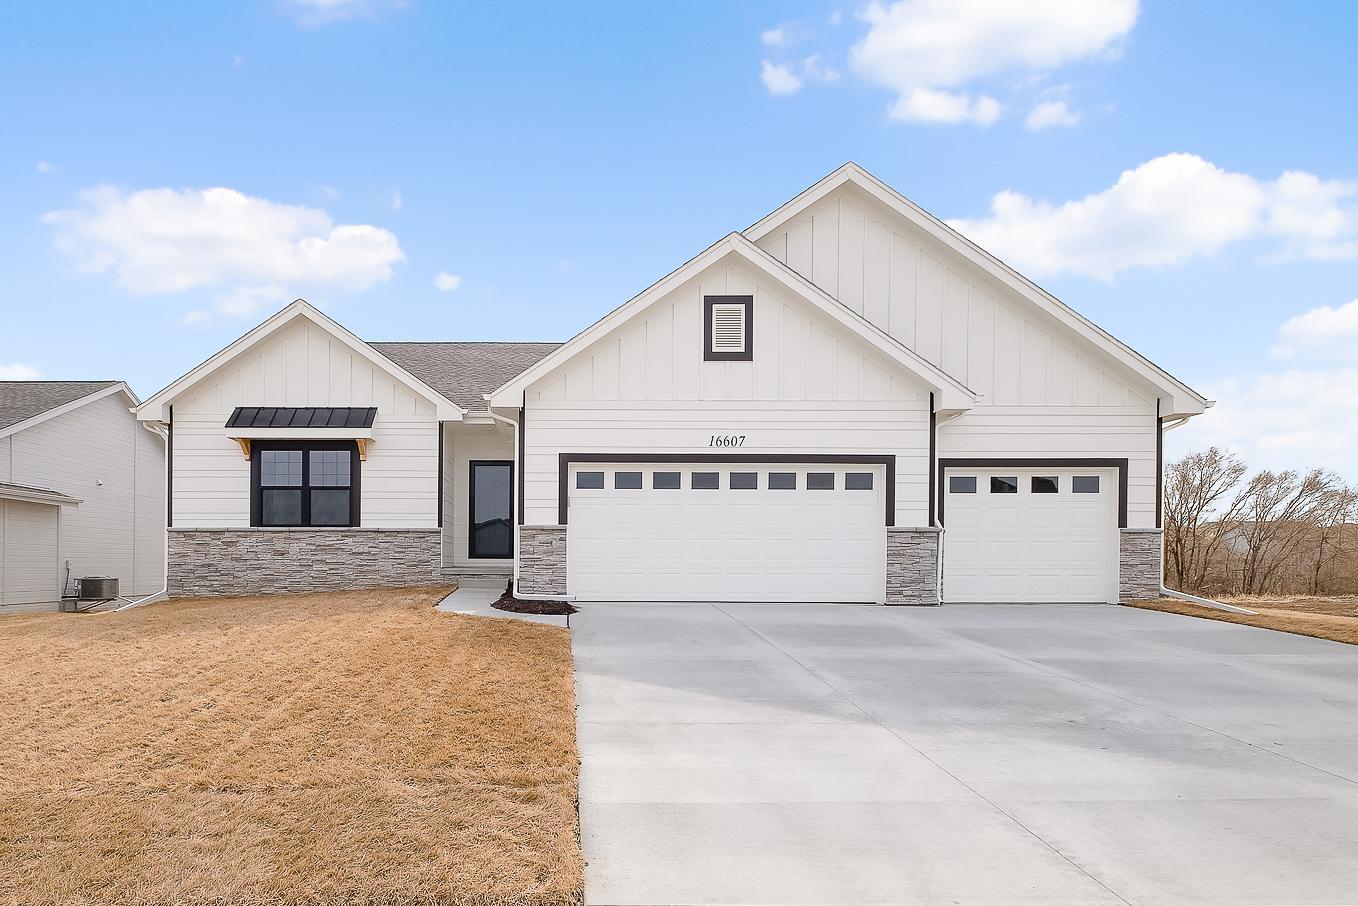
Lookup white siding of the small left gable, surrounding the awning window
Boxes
[174,319,439,528]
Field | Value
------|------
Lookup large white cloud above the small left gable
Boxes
[43,187,405,301]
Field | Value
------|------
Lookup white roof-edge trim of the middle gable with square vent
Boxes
[490,232,976,412]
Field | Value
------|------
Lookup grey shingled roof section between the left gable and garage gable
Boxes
[368,342,561,412]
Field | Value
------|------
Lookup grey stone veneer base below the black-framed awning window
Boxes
[166,528,441,598]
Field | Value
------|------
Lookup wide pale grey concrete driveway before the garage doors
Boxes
[570,604,1358,906]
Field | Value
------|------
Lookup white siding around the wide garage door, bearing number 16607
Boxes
[524,255,929,526]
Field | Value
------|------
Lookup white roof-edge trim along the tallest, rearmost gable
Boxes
[744,162,1211,416]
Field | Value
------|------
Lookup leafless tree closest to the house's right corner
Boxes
[1164,447,1245,592]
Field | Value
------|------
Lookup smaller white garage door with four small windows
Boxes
[941,467,1118,603]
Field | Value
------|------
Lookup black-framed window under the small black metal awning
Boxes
[250,440,360,527]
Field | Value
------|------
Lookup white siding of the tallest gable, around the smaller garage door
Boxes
[756,185,1158,528]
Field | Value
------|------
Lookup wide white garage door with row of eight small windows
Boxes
[566,463,887,602]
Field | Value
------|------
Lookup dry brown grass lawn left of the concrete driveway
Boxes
[0,588,583,906]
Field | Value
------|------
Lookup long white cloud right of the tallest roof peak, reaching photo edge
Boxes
[948,153,1358,280]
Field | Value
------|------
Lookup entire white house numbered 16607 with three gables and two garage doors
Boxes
[137,164,1210,603]
